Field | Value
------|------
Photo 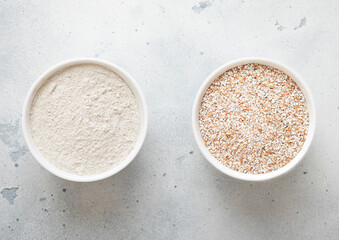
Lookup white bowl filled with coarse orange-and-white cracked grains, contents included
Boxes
[192,58,315,181]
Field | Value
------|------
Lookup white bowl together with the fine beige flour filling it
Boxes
[22,59,148,182]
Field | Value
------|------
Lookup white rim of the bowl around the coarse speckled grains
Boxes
[192,58,315,181]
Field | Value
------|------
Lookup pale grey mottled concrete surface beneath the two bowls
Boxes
[0,0,339,239]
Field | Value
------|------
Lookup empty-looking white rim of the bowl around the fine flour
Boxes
[22,58,148,182]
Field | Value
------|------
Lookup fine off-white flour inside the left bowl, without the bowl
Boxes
[30,64,140,175]
